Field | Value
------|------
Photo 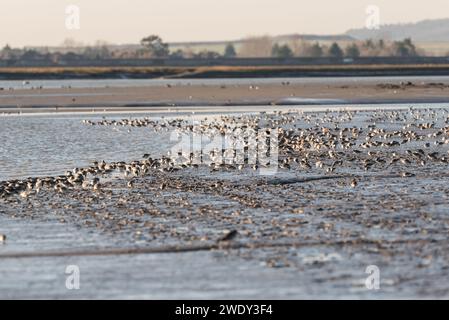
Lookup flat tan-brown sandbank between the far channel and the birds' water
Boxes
[0,77,449,112]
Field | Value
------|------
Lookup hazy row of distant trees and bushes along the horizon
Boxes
[0,35,424,62]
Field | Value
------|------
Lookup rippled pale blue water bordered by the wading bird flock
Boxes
[0,104,448,181]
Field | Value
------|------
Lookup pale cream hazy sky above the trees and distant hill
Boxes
[0,0,449,46]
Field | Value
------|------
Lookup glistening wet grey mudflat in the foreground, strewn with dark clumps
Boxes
[0,106,449,299]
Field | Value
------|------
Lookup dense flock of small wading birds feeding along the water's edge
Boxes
[0,108,449,200]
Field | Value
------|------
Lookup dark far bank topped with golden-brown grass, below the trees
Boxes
[0,63,449,80]
